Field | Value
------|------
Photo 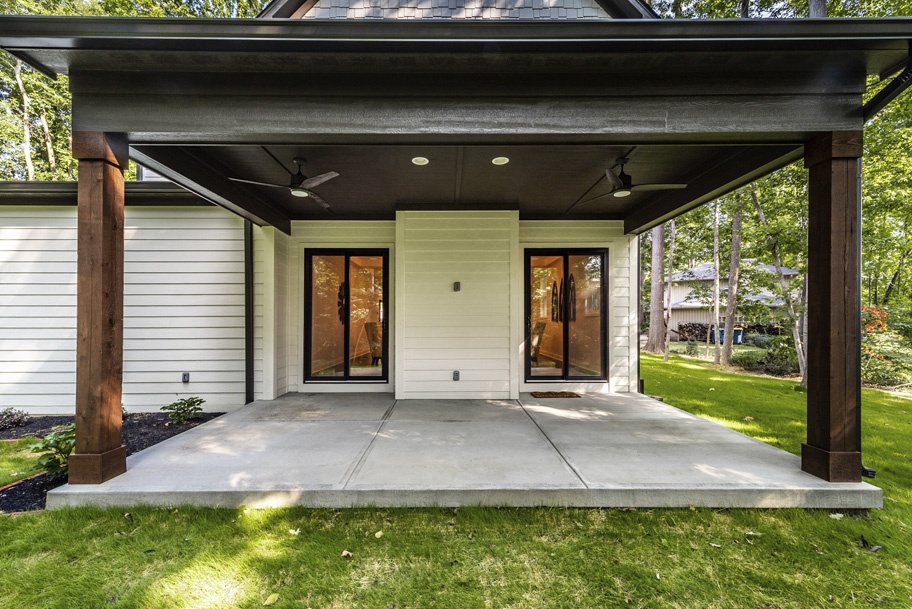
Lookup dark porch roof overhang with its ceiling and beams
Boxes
[0,17,912,232]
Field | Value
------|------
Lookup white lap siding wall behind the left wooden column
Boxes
[0,206,244,414]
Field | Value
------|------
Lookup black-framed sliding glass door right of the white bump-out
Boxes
[526,250,607,380]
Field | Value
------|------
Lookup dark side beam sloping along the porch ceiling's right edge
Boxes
[624,146,803,234]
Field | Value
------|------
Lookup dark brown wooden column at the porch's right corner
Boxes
[801,131,862,482]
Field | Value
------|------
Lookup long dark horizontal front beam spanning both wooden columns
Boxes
[73,94,862,144]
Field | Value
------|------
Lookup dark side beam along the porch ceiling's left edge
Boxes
[130,146,291,234]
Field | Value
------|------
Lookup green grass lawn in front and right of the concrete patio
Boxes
[0,357,912,609]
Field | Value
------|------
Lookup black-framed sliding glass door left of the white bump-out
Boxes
[305,250,389,381]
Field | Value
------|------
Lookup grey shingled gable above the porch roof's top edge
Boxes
[259,0,659,20]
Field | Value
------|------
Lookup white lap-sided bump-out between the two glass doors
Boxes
[397,212,515,398]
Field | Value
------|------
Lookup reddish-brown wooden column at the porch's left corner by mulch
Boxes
[69,132,127,484]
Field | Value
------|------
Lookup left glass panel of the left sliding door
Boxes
[310,255,345,377]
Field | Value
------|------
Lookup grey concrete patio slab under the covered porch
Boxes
[48,394,882,509]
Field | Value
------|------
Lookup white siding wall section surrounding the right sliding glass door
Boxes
[519,220,639,393]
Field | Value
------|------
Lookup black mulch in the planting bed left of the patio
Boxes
[0,412,224,513]
